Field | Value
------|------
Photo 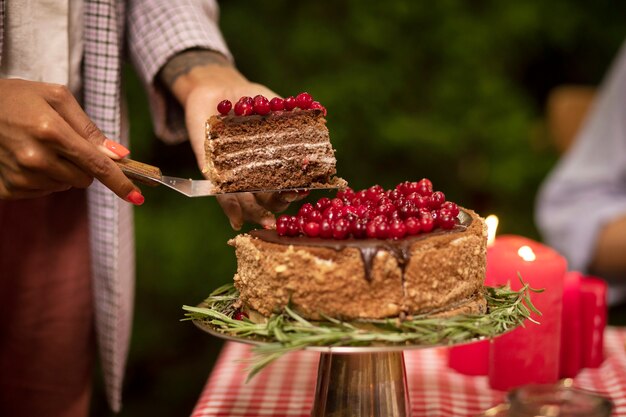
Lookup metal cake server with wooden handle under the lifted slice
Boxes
[115,158,340,197]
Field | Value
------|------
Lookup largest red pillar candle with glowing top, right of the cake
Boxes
[486,236,567,390]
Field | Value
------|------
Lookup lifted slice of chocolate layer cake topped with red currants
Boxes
[204,93,342,192]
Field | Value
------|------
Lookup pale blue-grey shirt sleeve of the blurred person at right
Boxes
[536,39,626,272]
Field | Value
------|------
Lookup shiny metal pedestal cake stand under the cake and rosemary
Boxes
[193,320,500,417]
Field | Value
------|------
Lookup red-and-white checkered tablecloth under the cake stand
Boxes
[192,327,626,417]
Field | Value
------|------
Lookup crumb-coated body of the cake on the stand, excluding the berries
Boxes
[229,209,487,320]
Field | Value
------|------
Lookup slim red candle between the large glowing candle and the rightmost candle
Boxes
[559,271,583,378]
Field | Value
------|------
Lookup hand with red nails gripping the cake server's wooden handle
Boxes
[0,79,143,204]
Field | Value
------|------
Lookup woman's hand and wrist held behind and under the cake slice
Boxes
[161,51,306,230]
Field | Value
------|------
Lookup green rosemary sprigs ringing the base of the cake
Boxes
[183,277,543,379]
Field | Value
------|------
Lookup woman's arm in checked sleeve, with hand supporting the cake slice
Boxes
[129,0,305,229]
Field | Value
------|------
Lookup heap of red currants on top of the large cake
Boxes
[276,178,459,239]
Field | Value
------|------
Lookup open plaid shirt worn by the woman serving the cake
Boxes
[0,0,230,411]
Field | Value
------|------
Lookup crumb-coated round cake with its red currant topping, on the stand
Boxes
[229,179,487,320]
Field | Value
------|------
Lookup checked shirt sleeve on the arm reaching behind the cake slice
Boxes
[127,0,232,143]
